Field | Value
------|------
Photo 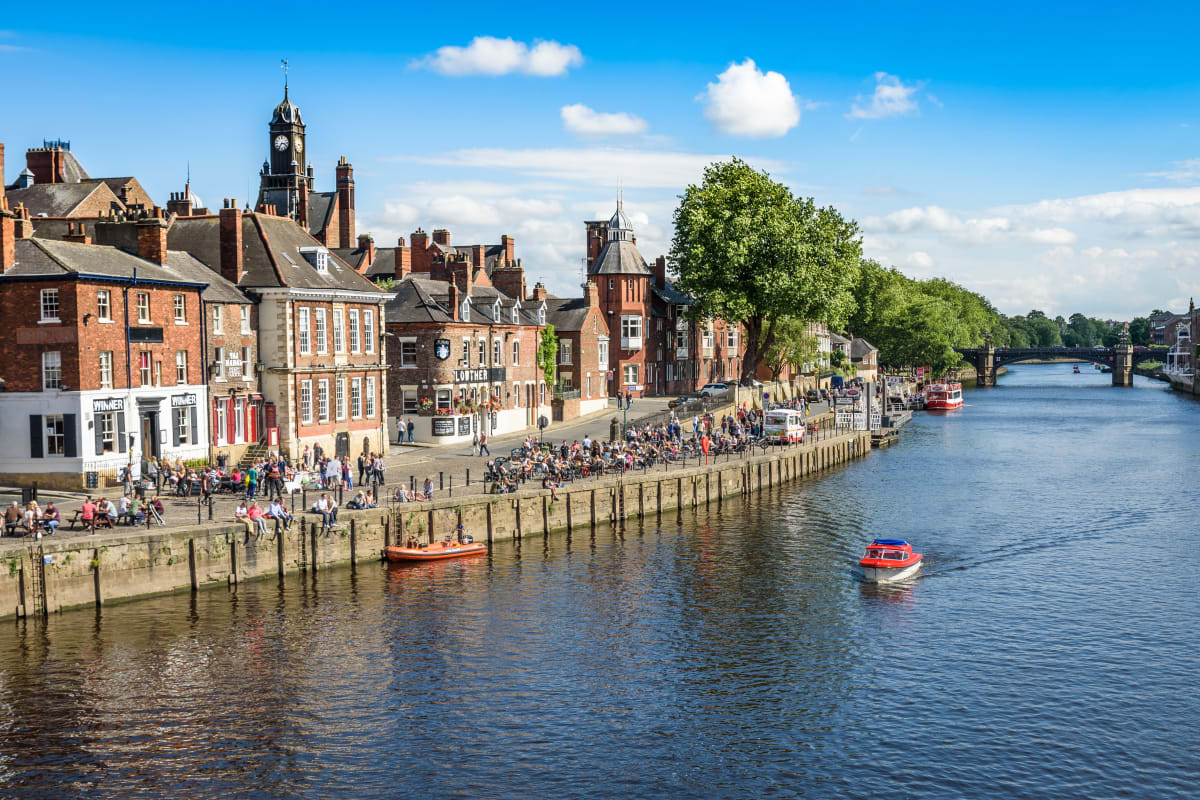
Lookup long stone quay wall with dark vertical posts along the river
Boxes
[0,433,871,618]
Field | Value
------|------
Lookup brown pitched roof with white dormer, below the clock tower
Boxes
[167,213,379,291]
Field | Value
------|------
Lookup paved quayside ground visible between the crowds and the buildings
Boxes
[0,397,828,535]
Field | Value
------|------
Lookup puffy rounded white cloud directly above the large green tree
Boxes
[696,59,800,139]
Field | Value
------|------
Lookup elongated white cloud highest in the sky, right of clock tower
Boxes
[409,36,583,78]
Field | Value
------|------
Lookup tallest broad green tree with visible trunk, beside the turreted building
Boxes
[671,158,863,379]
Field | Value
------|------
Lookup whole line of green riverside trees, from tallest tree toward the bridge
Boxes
[671,158,1132,378]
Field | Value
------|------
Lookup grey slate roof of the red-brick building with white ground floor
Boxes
[0,237,208,285]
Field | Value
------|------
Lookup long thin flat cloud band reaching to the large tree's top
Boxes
[384,148,787,191]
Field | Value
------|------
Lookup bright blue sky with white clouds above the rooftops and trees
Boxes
[0,0,1200,319]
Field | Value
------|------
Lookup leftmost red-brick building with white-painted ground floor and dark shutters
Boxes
[0,206,208,489]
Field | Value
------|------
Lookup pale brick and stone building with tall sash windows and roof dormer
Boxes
[168,200,392,456]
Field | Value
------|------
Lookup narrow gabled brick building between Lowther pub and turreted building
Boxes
[549,281,611,420]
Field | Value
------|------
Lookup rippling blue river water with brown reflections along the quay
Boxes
[0,365,1200,800]
